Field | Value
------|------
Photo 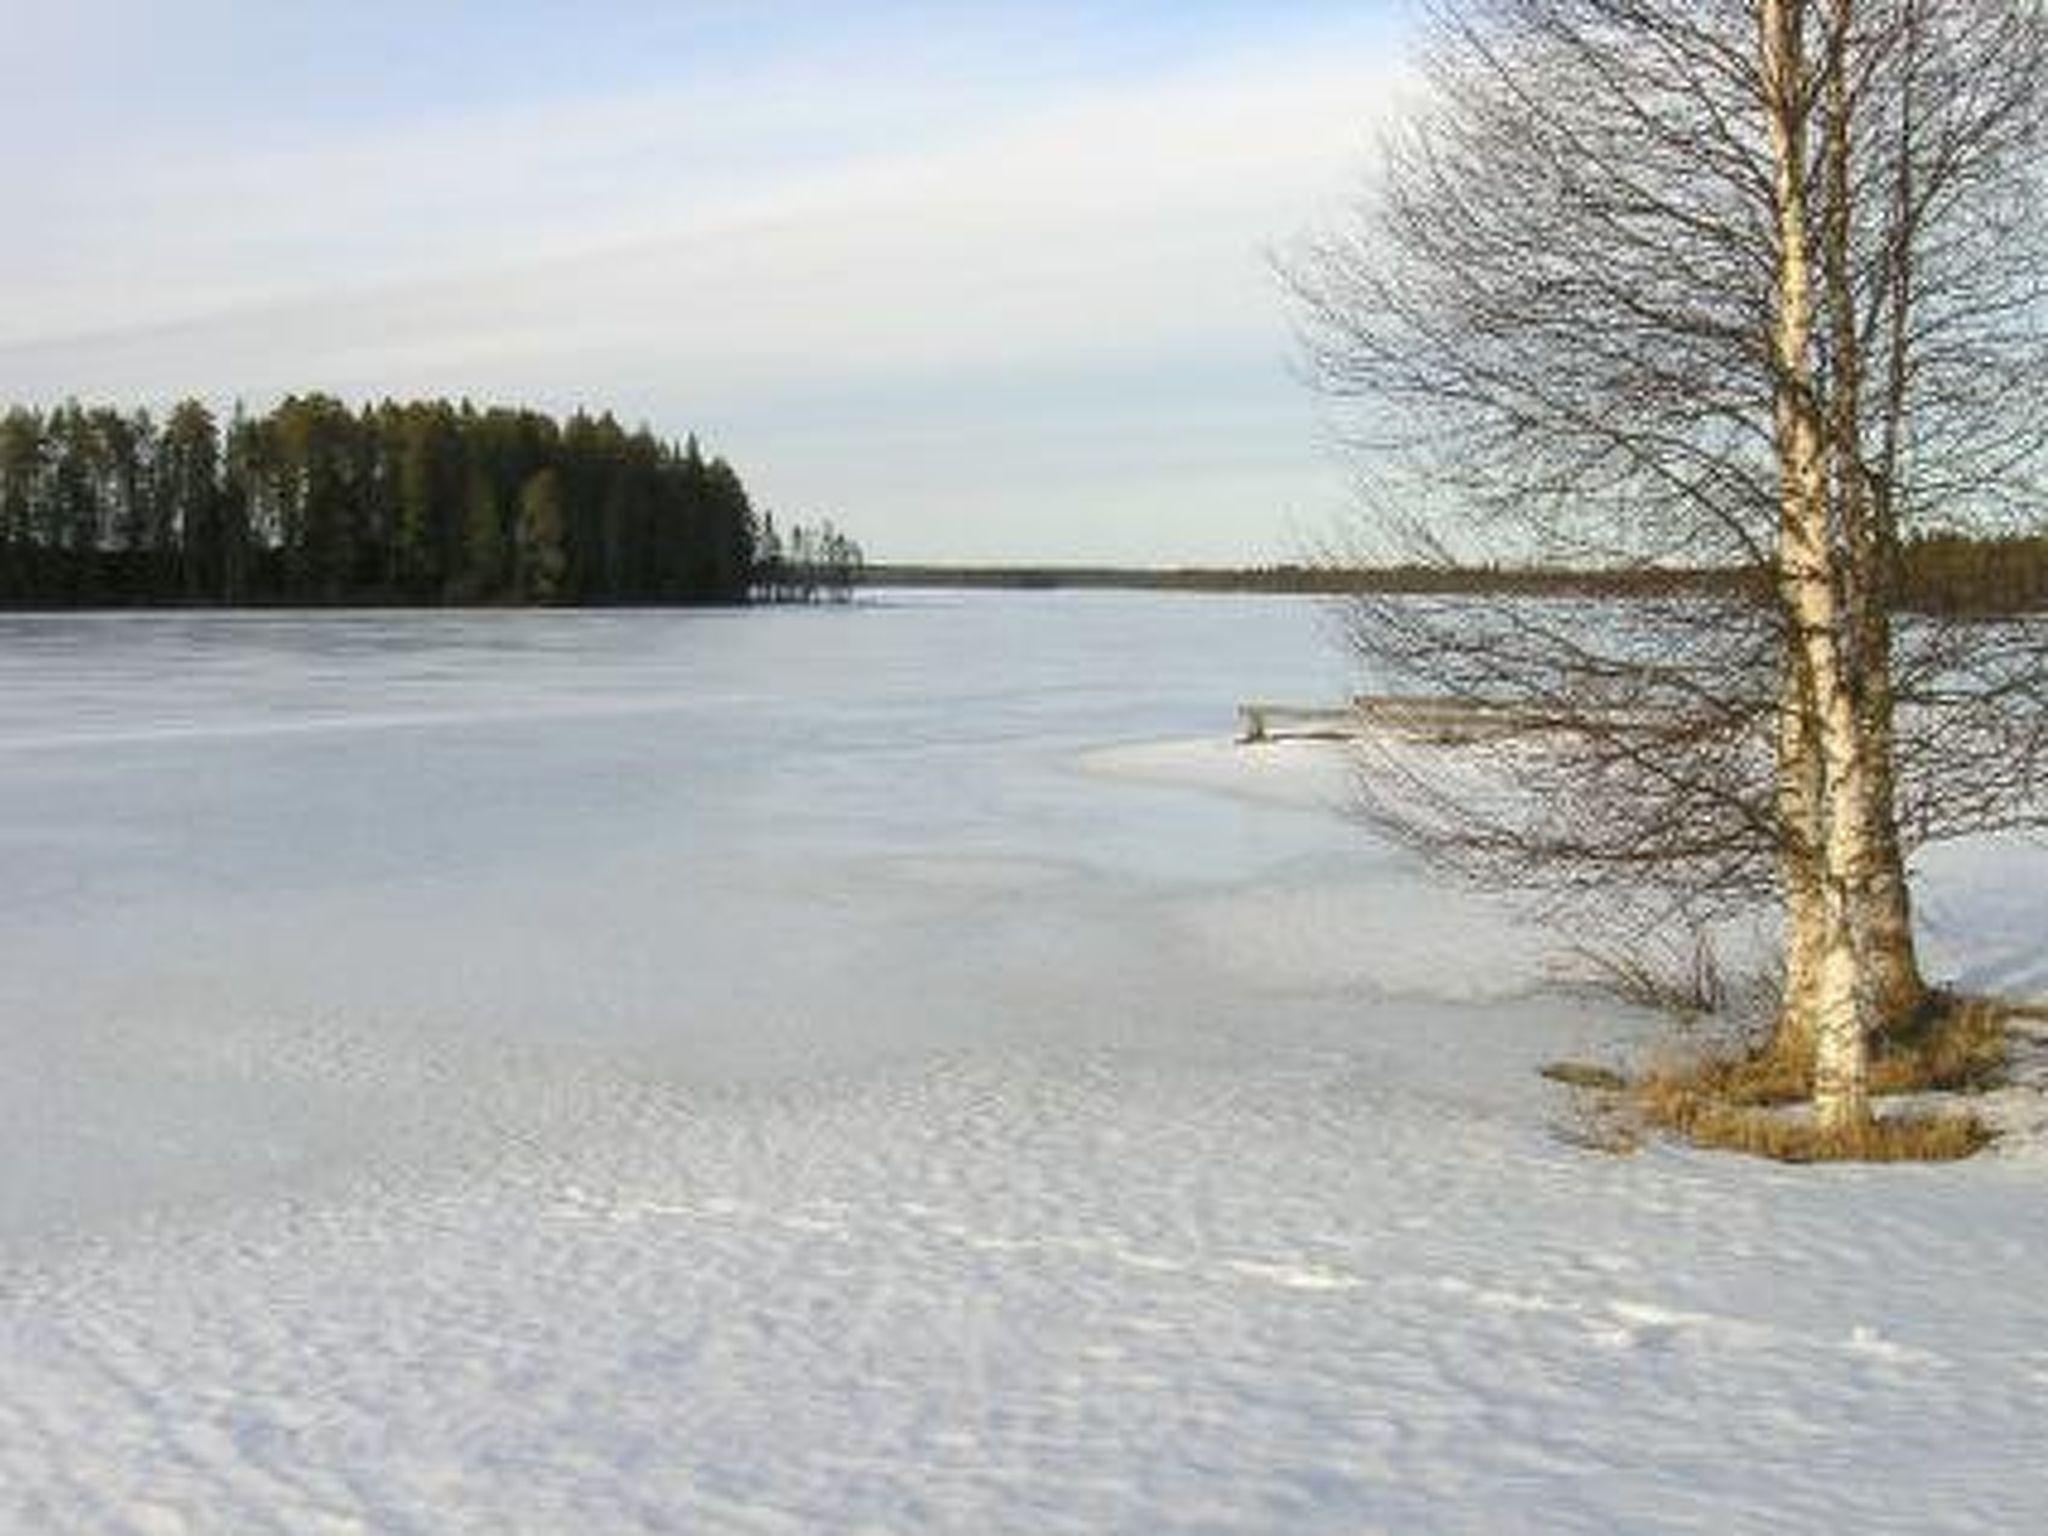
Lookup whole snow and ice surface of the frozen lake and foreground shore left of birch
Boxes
[0,594,2048,1536]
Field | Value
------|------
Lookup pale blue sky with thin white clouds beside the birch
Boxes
[0,0,1405,565]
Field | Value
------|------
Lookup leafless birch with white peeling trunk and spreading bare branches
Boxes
[1288,0,2048,1122]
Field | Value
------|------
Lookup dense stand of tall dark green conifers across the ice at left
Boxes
[0,395,790,606]
